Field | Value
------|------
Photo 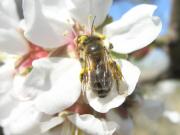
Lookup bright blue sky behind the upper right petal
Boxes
[109,0,171,35]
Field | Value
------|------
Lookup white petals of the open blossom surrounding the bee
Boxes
[20,0,161,114]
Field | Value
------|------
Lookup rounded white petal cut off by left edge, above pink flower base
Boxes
[0,29,29,55]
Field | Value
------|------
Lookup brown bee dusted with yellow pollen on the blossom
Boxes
[76,35,122,98]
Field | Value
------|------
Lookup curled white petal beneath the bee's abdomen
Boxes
[86,60,140,113]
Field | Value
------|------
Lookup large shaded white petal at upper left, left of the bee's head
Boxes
[23,0,70,48]
